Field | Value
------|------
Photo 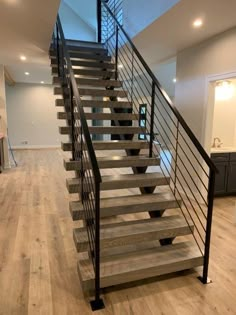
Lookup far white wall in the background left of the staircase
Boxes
[6,83,63,148]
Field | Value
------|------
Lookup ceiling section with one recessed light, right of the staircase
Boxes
[134,0,236,65]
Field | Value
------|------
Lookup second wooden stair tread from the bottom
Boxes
[73,215,194,252]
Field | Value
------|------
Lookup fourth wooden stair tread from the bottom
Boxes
[66,172,170,193]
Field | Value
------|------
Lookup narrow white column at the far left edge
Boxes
[0,64,10,168]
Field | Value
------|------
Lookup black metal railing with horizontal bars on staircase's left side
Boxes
[53,16,101,303]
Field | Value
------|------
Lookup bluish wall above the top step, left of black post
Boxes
[59,1,96,41]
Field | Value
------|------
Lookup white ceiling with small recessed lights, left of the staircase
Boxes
[0,0,60,83]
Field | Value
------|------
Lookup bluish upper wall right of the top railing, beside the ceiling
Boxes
[123,0,180,37]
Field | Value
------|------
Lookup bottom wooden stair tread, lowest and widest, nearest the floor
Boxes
[78,242,203,291]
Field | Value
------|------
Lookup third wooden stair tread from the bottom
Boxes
[69,193,181,220]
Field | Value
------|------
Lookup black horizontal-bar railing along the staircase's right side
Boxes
[101,0,217,283]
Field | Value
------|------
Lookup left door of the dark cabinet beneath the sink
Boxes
[215,162,229,195]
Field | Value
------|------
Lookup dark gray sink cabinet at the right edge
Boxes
[211,153,236,196]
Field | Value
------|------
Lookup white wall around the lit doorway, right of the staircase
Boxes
[175,28,236,152]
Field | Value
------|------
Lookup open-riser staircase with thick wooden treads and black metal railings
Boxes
[50,0,215,309]
